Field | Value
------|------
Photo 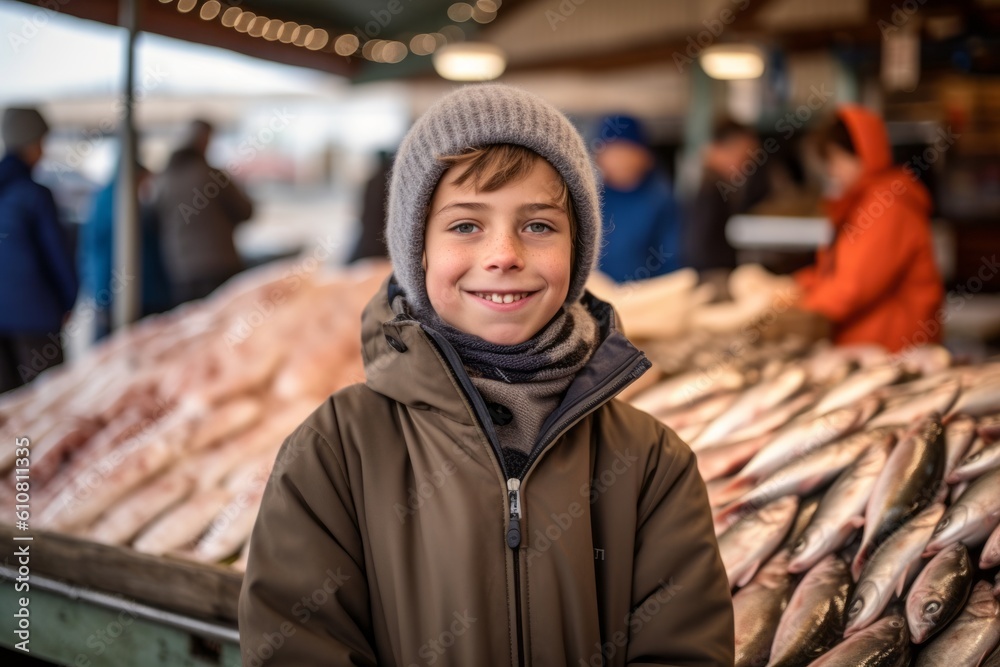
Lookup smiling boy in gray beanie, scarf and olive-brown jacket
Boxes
[240,85,733,667]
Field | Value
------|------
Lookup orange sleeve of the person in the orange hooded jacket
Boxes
[800,204,916,324]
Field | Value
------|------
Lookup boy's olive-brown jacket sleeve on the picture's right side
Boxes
[628,431,735,667]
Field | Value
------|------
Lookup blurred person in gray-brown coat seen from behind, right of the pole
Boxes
[156,120,253,303]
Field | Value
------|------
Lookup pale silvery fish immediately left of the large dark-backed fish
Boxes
[788,438,896,573]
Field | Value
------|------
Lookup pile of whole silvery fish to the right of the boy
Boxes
[631,339,1000,667]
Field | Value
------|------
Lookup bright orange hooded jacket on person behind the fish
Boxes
[795,105,944,352]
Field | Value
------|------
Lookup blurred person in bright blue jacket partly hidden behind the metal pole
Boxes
[77,165,172,340]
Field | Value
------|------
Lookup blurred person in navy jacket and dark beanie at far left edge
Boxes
[0,108,77,392]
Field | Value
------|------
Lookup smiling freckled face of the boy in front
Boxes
[424,158,573,345]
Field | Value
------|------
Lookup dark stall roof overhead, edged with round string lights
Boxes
[11,0,1000,82]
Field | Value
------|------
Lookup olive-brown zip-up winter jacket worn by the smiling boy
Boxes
[239,274,733,667]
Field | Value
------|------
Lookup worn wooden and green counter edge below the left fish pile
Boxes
[0,525,243,667]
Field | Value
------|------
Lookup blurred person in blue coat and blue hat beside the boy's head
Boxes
[591,115,680,282]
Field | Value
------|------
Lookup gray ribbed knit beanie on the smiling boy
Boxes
[386,84,601,313]
